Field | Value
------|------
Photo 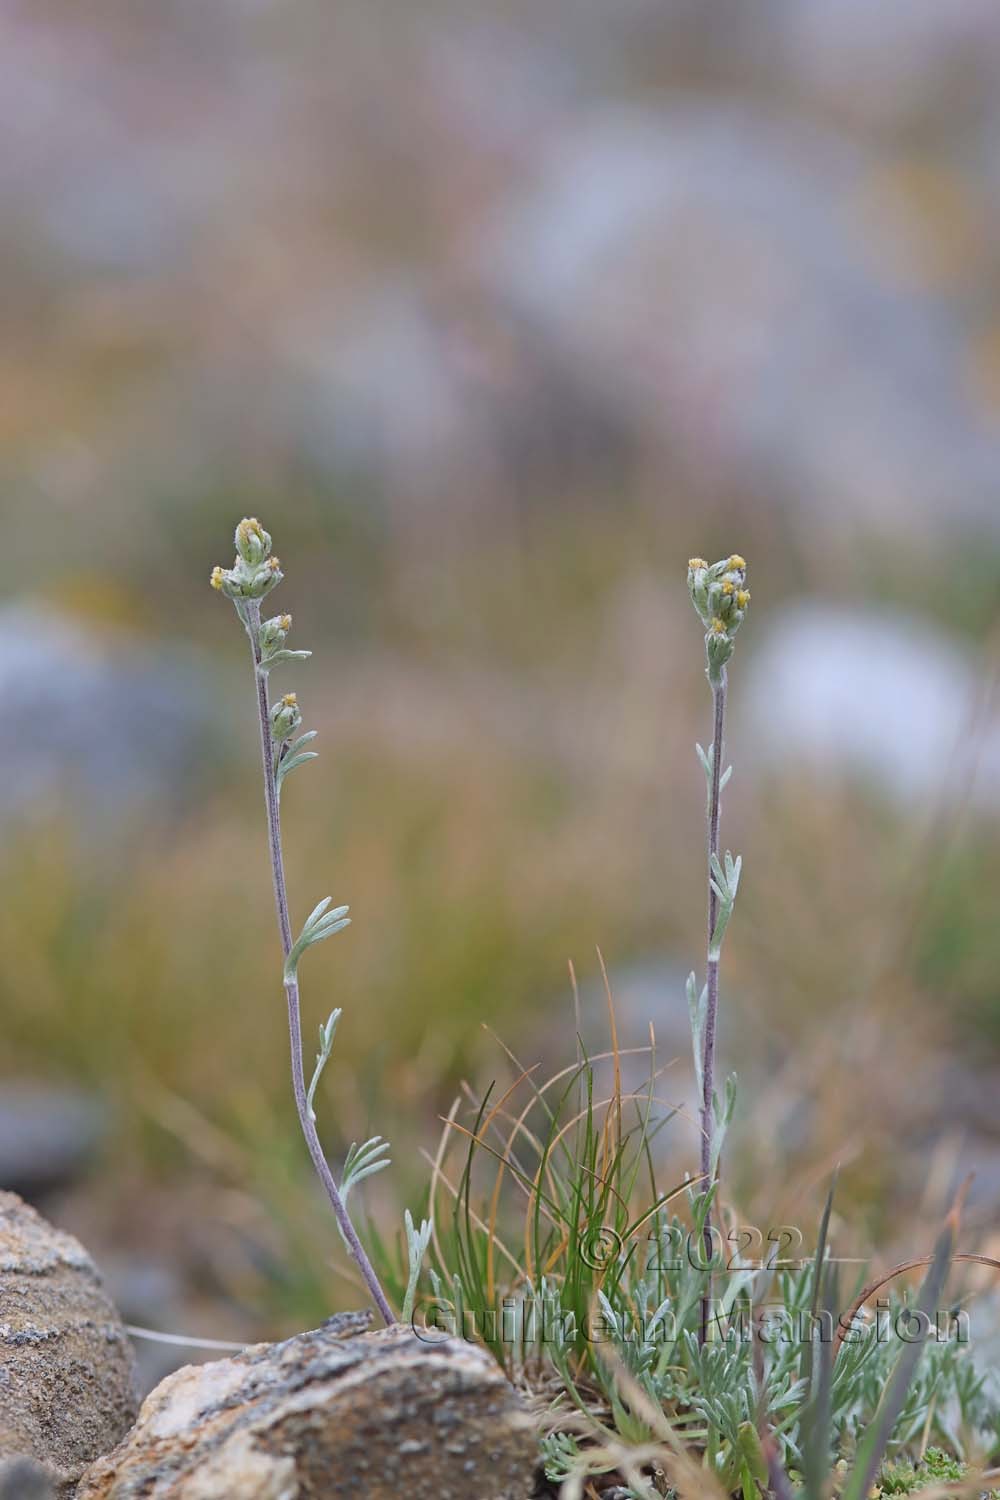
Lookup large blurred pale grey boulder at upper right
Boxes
[478,104,1000,536]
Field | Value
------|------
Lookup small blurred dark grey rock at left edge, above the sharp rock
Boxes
[0,1082,106,1200]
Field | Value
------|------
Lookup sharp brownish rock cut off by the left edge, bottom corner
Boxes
[0,1193,135,1496]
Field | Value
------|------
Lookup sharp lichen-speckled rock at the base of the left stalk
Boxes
[78,1325,537,1500]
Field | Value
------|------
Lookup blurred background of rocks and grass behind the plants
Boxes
[0,0,1000,1379]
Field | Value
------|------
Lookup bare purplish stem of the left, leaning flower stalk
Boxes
[246,600,396,1323]
